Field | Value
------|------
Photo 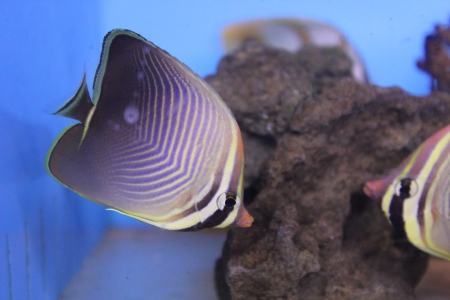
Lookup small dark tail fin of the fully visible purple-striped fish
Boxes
[53,74,94,124]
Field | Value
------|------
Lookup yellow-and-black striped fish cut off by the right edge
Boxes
[364,125,450,259]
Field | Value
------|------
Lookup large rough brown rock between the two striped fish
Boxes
[207,41,450,300]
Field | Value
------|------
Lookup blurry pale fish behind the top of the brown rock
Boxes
[222,18,368,83]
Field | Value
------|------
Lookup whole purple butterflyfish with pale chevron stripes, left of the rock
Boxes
[46,29,253,231]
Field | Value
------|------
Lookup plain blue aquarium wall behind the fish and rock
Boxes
[0,0,450,299]
